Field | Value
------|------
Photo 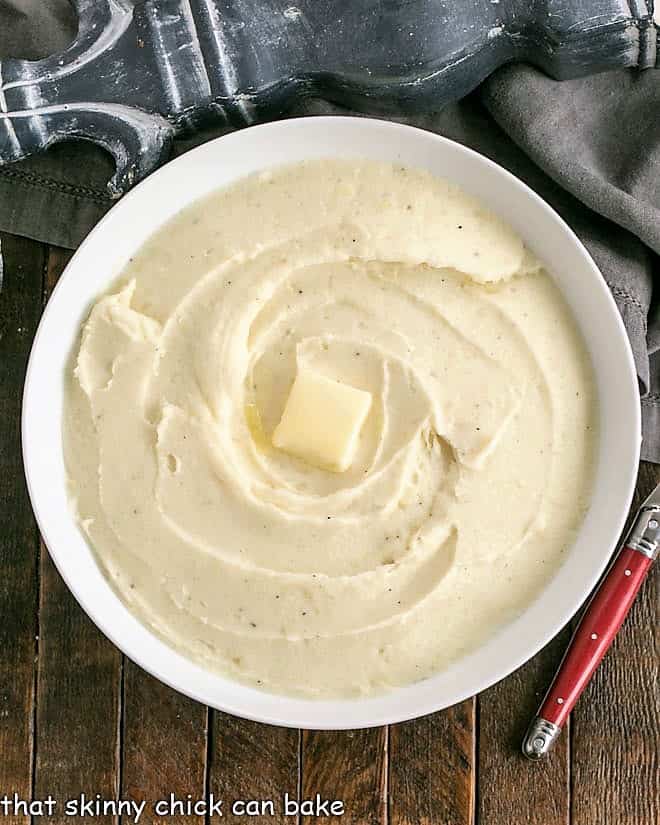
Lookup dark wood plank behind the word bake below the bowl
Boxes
[301,728,389,825]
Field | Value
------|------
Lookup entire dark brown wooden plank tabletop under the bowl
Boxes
[0,236,660,825]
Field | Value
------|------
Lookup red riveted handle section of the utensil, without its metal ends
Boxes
[538,547,653,727]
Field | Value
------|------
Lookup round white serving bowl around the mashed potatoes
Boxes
[22,117,641,728]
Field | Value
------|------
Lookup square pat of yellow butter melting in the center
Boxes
[273,367,371,473]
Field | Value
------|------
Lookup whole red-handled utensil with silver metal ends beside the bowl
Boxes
[522,485,660,760]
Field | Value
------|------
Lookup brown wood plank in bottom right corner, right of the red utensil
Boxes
[572,464,660,825]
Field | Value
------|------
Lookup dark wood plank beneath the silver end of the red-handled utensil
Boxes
[477,629,570,825]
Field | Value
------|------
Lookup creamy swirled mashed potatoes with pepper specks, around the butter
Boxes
[64,161,596,697]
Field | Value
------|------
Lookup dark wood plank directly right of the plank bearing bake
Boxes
[390,699,476,825]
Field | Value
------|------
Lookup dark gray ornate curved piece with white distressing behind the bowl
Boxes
[0,0,659,195]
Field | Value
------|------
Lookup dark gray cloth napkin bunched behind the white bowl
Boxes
[0,0,660,462]
